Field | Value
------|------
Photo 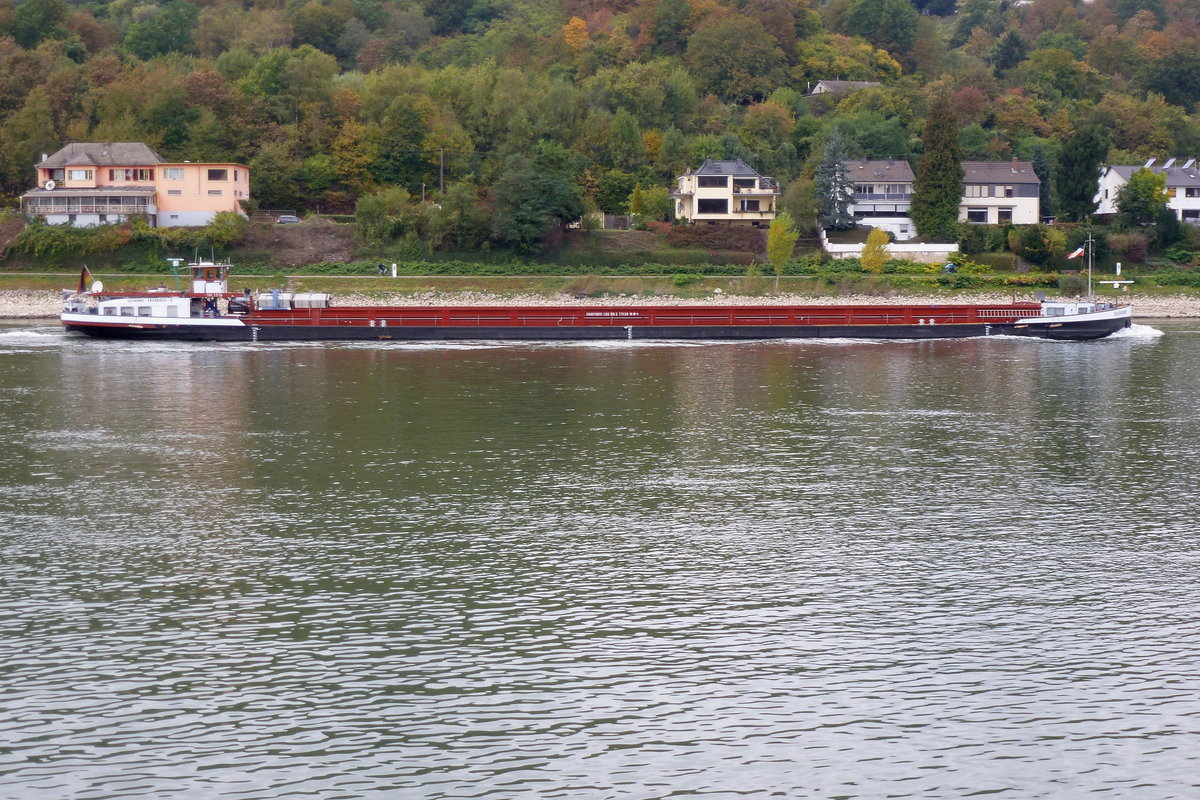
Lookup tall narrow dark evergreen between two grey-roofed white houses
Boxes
[908,95,962,241]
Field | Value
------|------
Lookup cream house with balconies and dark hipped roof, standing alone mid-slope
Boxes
[671,158,780,227]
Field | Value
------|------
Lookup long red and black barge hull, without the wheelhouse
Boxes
[62,302,1130,342]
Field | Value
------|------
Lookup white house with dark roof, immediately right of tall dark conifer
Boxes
[959,158,1042,225]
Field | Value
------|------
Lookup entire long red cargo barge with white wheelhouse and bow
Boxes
[60,261,1132,342]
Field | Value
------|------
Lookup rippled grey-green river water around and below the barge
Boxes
[0,321,1200,800]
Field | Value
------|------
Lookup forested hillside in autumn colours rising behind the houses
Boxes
[7,0,1200,249]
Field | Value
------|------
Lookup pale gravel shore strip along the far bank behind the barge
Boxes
[0,290,1200,319]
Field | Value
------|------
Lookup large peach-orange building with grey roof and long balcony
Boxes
[20,142,250,228]
